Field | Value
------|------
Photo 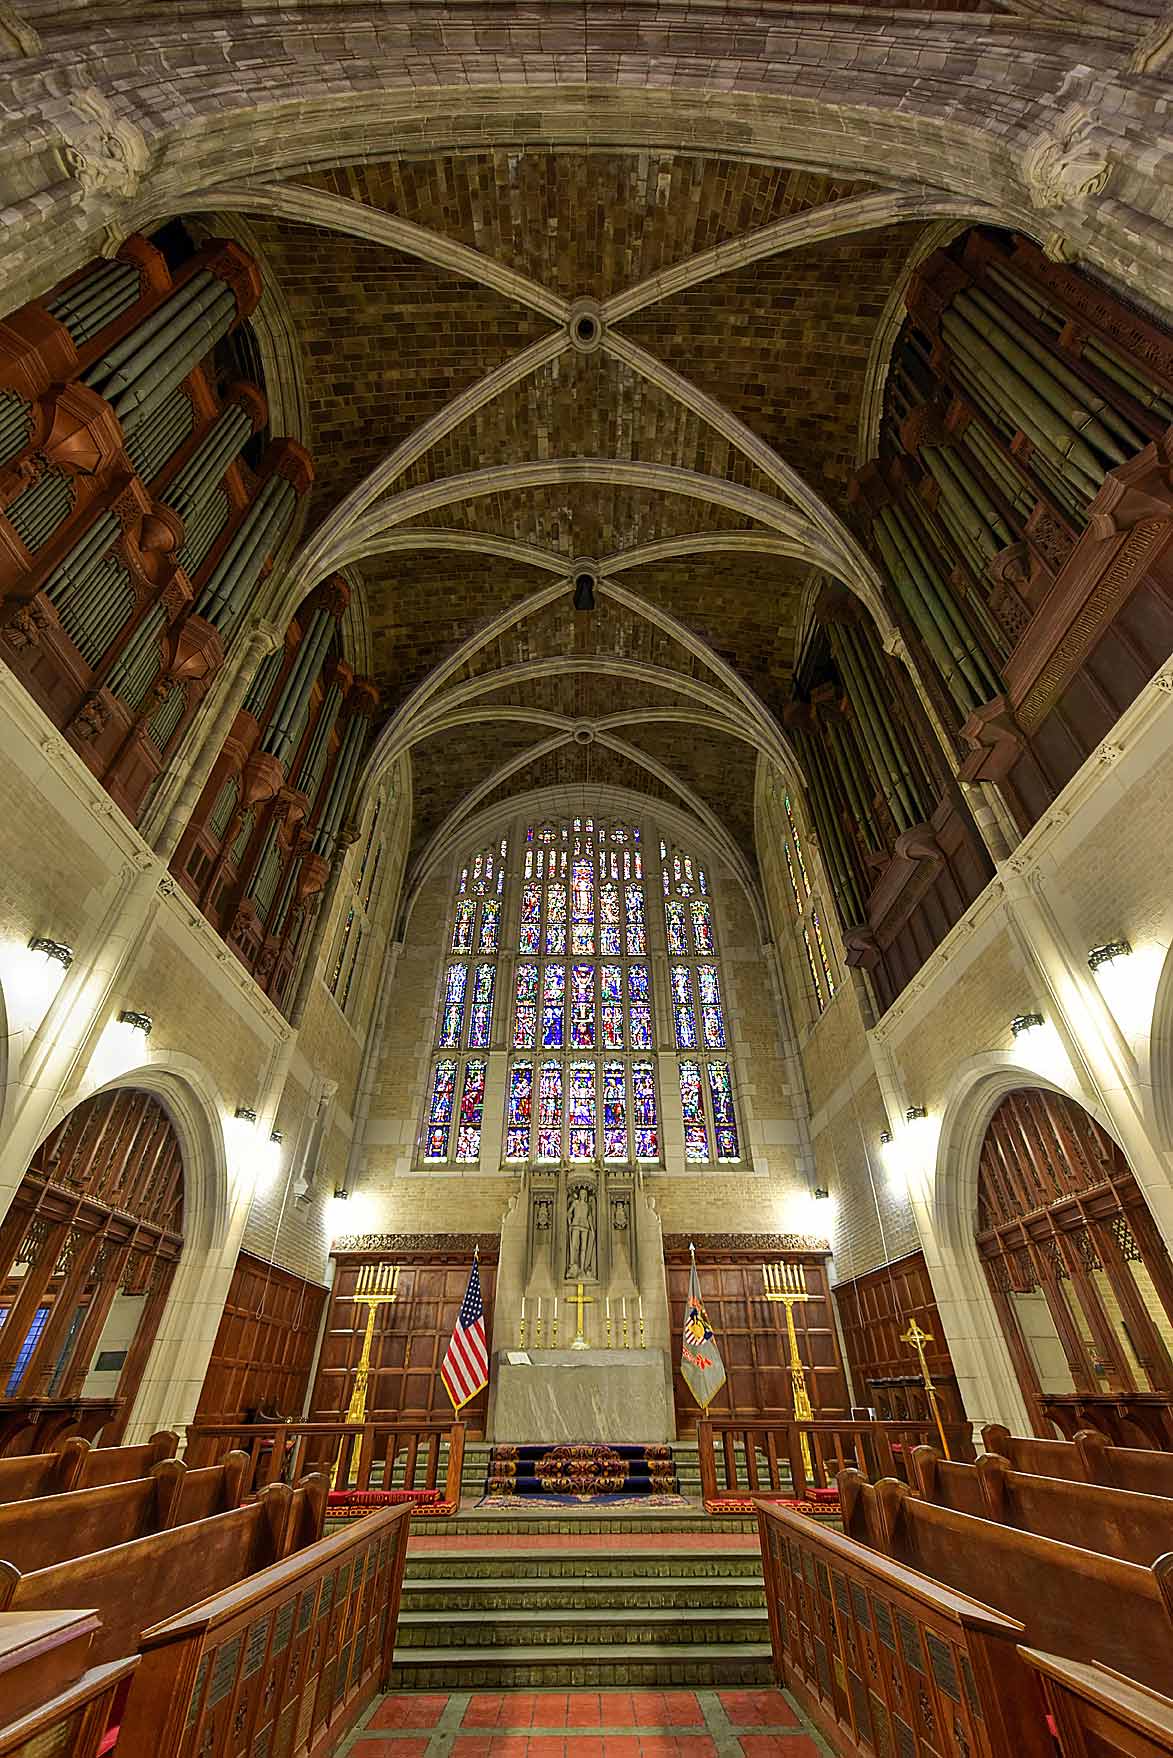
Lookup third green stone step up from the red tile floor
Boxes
[403,1575,765,1614]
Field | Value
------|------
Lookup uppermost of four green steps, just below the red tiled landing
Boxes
[406,1547,761,1586]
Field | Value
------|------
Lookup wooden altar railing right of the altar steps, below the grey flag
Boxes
[696,1420,974,1501]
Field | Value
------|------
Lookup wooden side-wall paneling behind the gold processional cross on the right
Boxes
[834,1252,965,1422]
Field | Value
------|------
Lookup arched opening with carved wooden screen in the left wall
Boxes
[0,1088,183,1452]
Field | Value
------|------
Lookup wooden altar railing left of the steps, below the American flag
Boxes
[185,1422,464,1507]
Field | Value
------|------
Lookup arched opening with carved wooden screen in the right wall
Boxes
[976,1086,1173,1450]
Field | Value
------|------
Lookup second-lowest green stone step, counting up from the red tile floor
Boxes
[397,1605,769,1651]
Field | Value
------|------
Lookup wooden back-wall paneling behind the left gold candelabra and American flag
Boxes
[310,1236,498,1440]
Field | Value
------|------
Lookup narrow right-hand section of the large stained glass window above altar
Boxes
[659,842,740,1166]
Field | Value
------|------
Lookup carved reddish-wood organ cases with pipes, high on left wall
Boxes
[0,222,376,1004]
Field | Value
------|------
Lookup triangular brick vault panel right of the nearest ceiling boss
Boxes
[623,225,920,506]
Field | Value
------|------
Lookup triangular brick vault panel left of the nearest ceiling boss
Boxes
[242,220,550,522]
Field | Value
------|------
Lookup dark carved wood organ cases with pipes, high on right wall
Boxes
[788,230,1173,1007]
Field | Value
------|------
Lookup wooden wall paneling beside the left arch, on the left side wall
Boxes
[195,1252,325,1422]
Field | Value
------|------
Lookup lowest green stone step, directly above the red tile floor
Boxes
[390,1640,774,1691]
